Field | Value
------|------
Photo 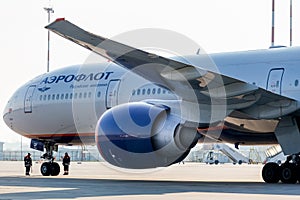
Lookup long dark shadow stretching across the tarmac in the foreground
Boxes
[0,177,300,199]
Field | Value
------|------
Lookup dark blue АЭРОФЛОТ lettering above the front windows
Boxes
[40,72,113,84]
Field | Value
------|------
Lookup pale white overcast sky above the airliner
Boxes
[0,0,300,146]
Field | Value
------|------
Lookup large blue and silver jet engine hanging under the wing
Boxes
[95,102,199,169]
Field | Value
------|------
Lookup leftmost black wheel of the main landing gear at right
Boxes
[262,163,280,183]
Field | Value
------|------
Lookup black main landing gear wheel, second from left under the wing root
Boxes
[280,163,298,183]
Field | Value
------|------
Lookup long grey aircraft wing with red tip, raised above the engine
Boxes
[46,19,299,119]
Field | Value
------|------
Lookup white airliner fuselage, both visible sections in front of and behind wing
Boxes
[4,47,300,144]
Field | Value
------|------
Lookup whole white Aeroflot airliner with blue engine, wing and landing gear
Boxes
[3,18,300,183]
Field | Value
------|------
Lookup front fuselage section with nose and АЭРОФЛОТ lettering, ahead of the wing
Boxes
[4,63,176,144]
